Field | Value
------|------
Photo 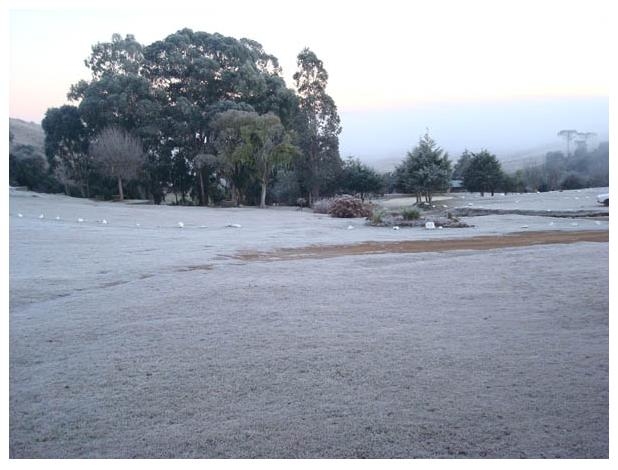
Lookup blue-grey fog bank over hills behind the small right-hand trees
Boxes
[340,97,609,171]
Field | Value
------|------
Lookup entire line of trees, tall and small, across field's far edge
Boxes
[9,29,609,207]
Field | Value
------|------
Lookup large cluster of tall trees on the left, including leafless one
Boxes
[36,29,344,206]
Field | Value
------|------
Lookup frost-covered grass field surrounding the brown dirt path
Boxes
[9,189,609,458]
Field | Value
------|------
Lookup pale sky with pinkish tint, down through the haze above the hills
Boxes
[8,0,615,163]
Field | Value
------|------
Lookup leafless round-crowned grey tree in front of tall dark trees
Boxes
[90,126,144,201]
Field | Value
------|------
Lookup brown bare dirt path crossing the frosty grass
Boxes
[235,230,609,261]
